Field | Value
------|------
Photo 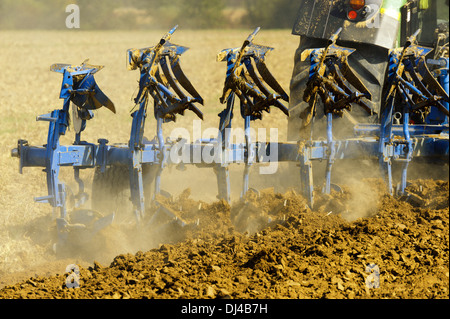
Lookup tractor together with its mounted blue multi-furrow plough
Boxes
[12,0,449,250]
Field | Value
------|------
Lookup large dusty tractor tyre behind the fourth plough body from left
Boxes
[288,37,388,141]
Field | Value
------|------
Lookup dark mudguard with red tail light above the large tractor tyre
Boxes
[292,0,399,49]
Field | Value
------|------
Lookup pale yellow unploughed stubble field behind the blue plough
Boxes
[0,27,298,286]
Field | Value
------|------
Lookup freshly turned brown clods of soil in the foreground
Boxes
[0,179,449,299]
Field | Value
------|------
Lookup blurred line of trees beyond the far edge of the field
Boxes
[0,0,299,30]
